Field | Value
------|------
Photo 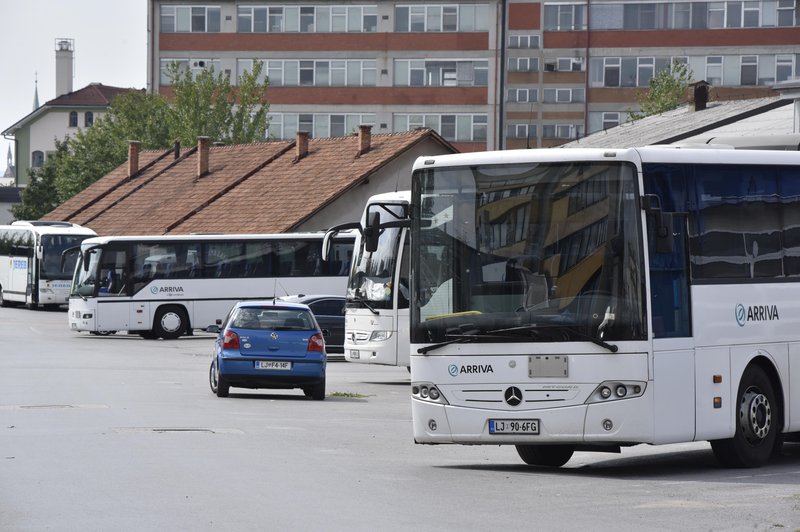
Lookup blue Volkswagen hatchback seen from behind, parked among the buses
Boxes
[209,300,327,401]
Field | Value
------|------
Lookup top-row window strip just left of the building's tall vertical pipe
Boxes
[394,4,489,33]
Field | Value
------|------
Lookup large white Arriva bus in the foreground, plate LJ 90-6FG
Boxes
[410,147,800,467]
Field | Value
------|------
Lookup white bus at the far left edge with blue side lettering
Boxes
[0,221,97,308]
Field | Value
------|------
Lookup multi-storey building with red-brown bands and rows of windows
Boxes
[148,0,800,151]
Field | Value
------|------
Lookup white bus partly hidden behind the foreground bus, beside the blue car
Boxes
[329,190,411,367]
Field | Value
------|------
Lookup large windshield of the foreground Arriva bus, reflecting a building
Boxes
[411,161,646,343]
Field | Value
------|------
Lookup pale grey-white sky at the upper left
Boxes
[0,0,147,176]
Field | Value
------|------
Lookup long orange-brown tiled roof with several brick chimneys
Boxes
[47,129,455,235]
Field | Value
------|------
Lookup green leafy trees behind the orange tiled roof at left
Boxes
[13,62,269,219]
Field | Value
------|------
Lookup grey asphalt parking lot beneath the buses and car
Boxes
[0,308,800,531]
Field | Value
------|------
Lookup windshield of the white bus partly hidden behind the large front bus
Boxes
[347,206,403,309]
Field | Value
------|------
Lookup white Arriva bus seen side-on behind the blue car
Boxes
[69,232,353,339]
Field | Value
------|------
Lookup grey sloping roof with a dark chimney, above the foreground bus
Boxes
[559,96,792,148]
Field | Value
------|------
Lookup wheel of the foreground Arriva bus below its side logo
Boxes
[711,365,781,467]
